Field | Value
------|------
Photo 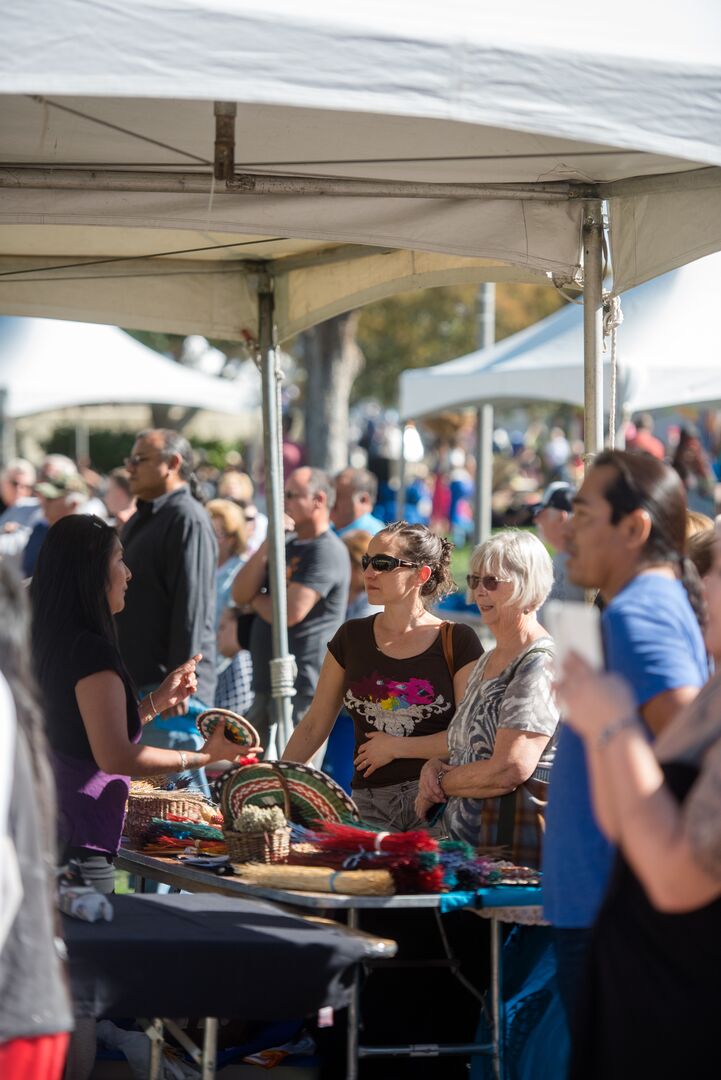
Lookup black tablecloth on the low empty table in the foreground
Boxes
[63,893,370,1021]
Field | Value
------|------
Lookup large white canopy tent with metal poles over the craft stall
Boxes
[0,0,721,751]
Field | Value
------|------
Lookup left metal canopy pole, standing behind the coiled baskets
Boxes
[258,273,295,756]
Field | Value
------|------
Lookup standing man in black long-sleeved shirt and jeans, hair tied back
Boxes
[118,429,218,785]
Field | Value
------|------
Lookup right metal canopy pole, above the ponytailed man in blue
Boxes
[583,199,603,461]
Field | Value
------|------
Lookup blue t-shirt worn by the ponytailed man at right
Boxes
[543,573,708,929]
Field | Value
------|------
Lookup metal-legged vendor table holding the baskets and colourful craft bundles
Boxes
[115,848,543,1080]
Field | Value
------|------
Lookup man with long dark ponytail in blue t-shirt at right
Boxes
[543,450,708,1028]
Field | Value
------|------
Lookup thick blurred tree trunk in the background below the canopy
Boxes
[302,311,365,473]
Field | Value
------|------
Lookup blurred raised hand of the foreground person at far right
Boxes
[556,652,637,739]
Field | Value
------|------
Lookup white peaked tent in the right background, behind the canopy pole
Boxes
[400,255,721,419]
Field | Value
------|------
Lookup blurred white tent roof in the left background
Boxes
[0,319,259,419]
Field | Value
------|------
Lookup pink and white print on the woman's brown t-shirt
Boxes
[343,672,452,735]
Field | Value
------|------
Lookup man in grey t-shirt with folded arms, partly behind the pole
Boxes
[233,468,351,750]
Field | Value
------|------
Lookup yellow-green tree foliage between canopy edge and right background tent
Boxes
[353,282,563,405]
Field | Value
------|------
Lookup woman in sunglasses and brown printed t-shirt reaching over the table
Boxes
[283,522,482,831]
